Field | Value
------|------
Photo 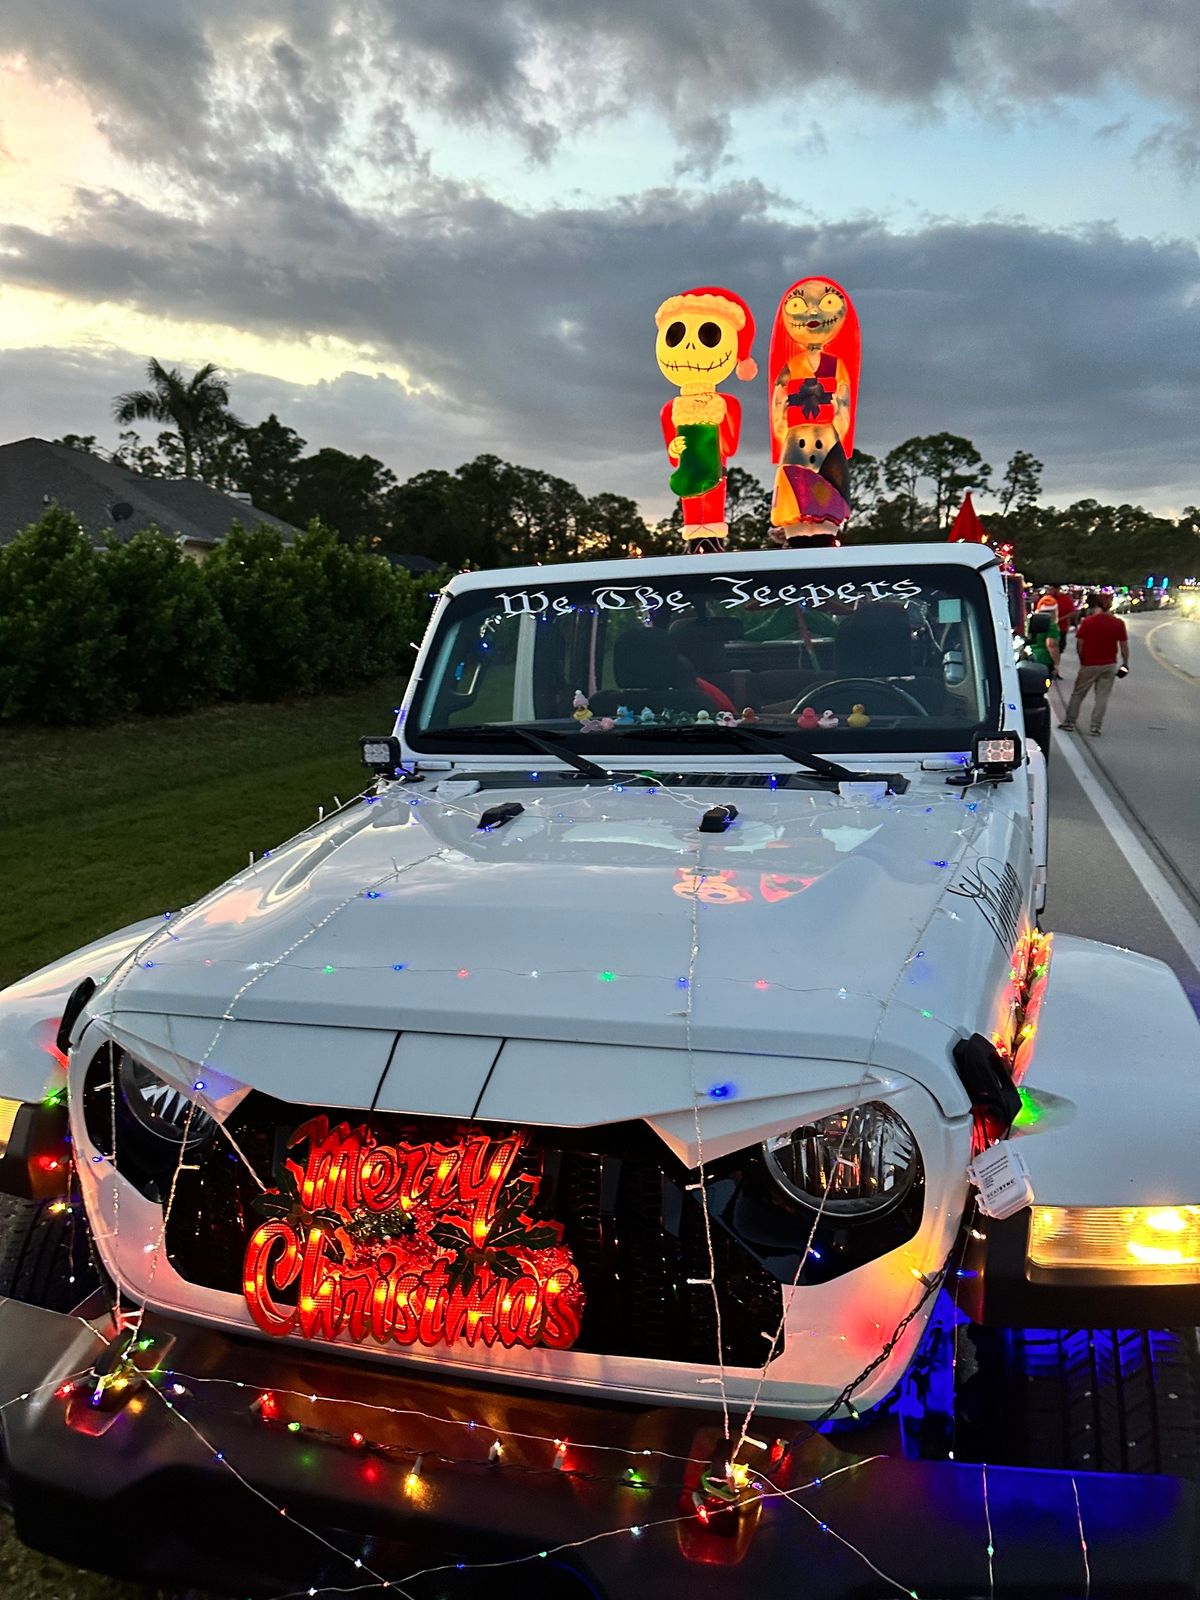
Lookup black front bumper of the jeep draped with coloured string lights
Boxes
[0,1301,1200,1600]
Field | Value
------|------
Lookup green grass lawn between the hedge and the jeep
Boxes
[0,683,400,986]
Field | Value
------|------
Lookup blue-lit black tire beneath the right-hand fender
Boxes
[963,1328,1200,1478]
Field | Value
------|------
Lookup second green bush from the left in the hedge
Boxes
[101,531,230,715]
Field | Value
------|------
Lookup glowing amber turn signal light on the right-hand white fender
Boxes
[1027,1205,1200,1283]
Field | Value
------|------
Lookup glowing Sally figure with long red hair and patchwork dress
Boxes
[768,278,859,546]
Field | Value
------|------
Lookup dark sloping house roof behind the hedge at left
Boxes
[0,438,299,544]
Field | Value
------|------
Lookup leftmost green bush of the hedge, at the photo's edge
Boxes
[0,506,122,723]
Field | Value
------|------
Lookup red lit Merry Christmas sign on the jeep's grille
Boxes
[242,1117,584,1350]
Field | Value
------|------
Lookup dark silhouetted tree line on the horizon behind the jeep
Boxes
[51,362,1200,584]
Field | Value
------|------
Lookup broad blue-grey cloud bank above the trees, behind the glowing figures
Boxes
[0,184,1200,509]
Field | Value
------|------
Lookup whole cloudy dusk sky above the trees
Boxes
[0,0,1200,515]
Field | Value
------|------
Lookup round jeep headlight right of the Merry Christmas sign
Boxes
[763,1101,920,1221]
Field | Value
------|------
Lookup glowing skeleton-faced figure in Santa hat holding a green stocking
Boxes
[654,288,758,554]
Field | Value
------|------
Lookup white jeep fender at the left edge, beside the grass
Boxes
[0,917,163,1104]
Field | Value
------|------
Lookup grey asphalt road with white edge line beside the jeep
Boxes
[1043,610,1200,1011]
